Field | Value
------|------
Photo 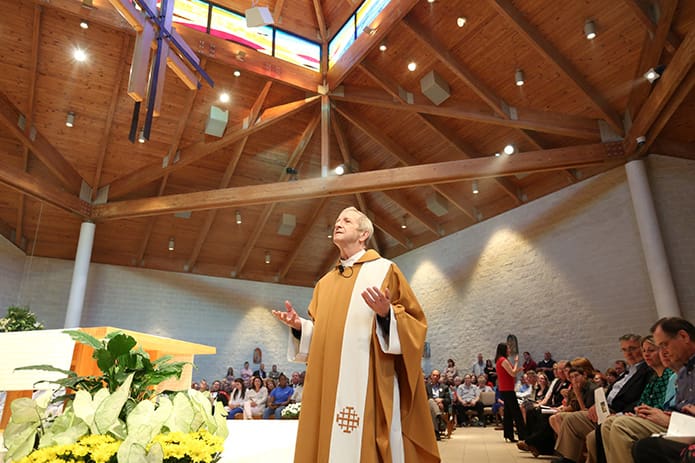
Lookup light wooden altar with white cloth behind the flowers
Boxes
[0,326,217,430]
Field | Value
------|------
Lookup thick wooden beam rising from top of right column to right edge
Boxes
[624,27,695,155]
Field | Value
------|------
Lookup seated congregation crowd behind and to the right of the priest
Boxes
[192,318,695,463]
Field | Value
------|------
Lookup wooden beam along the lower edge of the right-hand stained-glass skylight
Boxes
[327,0,418,90]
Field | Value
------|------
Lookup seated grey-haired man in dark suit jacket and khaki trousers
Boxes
[555,334,651,462]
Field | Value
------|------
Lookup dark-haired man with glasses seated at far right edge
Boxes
[632,317,695,463]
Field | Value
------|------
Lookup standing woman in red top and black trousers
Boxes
[495,343,526,442]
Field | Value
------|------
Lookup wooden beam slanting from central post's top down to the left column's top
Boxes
[109,97,318,198]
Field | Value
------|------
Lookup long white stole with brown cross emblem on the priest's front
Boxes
[329,258,391,463]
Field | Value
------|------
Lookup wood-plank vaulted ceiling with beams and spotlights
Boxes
[0,0,695,286]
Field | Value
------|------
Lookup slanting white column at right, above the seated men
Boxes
[625,160,682,318]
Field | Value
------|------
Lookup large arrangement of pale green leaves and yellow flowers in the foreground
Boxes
[4,331,228,463]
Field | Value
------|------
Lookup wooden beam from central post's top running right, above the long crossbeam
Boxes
[331,87,601,141]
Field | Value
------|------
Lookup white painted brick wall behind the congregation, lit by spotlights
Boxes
[0,156,695,379]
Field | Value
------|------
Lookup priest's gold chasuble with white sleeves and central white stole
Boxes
[288,250,440,463]
